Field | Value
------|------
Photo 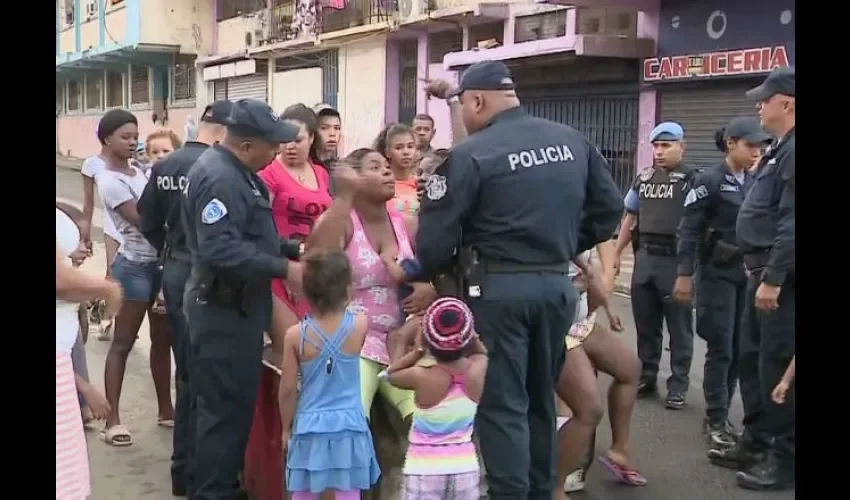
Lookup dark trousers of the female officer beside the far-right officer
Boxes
[695,262,747,423]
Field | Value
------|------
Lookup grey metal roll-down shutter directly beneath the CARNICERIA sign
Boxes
[658,78,760,166]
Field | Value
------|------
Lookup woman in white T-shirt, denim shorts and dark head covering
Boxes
[97,109,174,446]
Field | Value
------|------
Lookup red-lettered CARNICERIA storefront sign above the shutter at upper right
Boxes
[643,45,788,82]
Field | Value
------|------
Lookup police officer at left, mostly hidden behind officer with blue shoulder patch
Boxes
[138,101,232,496]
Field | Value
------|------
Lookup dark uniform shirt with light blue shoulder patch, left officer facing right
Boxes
[182,146,287,282]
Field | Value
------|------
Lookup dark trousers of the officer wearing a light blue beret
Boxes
[631,248,694,393]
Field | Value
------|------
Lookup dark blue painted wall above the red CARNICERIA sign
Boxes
[658,0,797,64]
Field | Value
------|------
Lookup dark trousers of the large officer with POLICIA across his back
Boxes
[468,273,578,500]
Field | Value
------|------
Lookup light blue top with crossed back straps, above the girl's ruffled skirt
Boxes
[292,312,368,435]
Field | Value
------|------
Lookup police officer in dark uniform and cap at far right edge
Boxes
[708,64,796,490]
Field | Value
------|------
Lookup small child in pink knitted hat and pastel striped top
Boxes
[382,297,487,500]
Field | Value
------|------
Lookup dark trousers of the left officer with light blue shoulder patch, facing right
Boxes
[185,287,271,500]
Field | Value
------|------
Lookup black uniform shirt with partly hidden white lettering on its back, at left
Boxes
[138,142,209,252]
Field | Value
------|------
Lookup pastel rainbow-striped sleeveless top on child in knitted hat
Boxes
[404,365,478,476]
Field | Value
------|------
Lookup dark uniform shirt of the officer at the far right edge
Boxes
[737,129,797,286]
